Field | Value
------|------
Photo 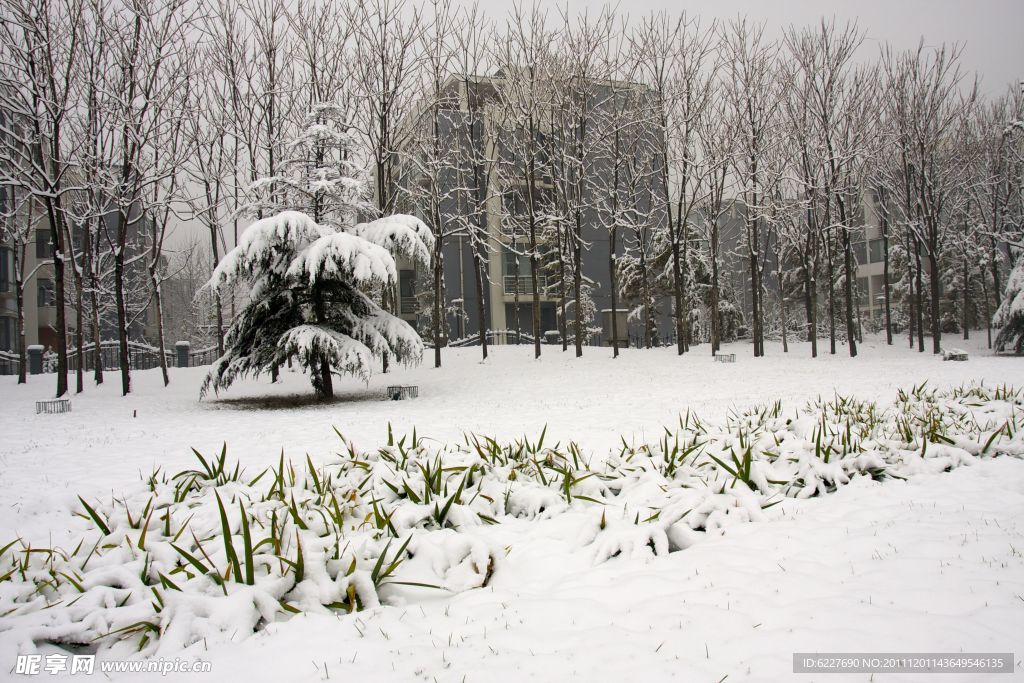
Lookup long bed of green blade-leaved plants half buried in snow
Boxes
[0,384,1024,657]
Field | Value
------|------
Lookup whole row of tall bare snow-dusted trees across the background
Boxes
[0,0,1024,395]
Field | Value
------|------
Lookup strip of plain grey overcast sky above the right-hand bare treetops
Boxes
[479,0,1024,95]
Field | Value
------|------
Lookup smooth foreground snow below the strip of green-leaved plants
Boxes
[94,459,1024,683]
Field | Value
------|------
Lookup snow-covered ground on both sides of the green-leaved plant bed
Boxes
[0,339,1024,681]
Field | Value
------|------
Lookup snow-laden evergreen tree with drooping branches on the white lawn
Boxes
[202,211,433,397]
